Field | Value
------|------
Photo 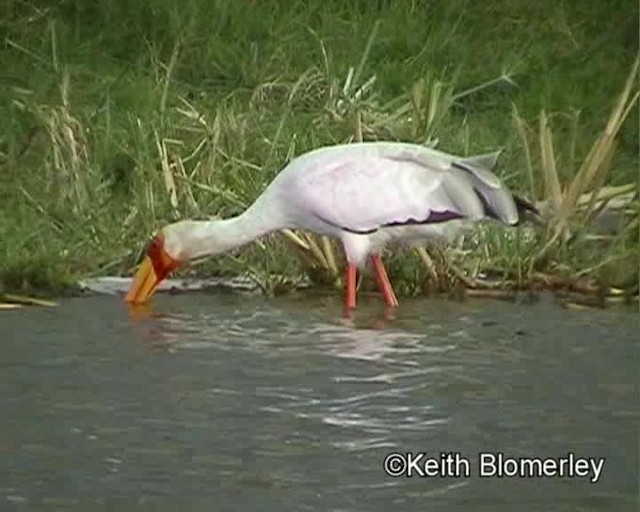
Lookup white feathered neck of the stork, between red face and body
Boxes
[178,194,287,259]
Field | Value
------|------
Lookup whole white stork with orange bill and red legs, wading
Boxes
[126,142,537,310]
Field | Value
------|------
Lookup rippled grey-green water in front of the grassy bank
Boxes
[0,293,640,512]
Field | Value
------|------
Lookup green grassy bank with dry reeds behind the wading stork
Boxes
[0,0,639,304]
